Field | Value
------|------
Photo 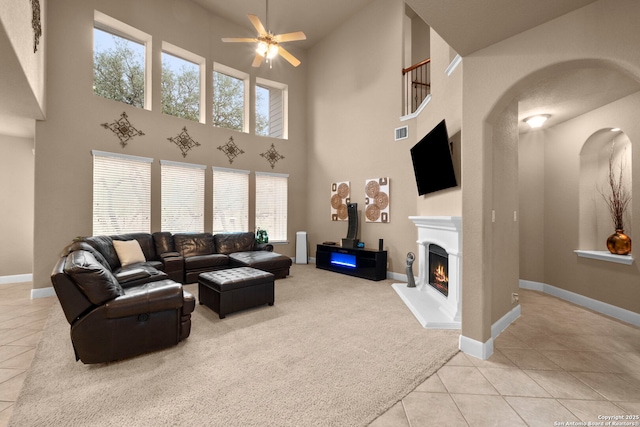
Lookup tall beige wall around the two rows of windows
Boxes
[34,0,308,288]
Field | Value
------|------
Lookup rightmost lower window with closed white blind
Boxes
[256,172,289,242]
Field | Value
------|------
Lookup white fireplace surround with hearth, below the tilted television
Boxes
[392,216,462,329]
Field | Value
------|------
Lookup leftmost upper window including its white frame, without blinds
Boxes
[93,11,151,110]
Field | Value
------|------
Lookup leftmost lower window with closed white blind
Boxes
[92,150,153,236]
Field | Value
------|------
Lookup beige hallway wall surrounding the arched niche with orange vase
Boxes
[543,93,640,313]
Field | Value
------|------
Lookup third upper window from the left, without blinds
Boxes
[213,63,249,132]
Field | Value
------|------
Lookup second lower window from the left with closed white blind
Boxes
[160,160,206,233]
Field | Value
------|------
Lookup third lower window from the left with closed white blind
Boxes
[213,166,249,234]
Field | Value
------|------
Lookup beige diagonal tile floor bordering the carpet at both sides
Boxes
[0,283,640,427]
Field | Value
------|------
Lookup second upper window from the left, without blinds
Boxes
[161,42,205,123]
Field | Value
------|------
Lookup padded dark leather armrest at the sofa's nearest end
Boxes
[104,279,184,319]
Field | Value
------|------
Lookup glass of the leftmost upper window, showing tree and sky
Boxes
[93,28,145,108]
